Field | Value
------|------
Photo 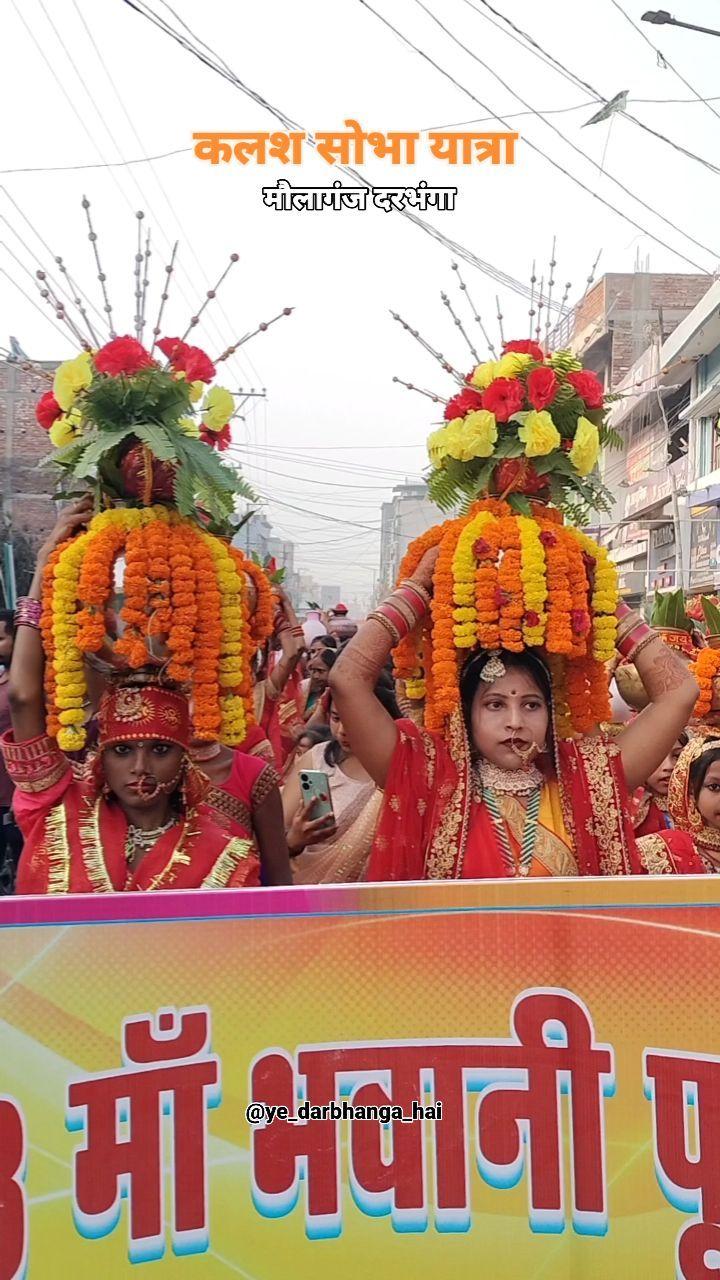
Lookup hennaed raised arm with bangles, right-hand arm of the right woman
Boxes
[618,604,700,791]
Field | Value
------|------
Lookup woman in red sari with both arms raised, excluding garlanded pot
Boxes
[331,549,700,881]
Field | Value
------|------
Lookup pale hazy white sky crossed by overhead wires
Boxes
[0,0,720,595]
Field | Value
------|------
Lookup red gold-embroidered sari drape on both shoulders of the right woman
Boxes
[366,712,703,881]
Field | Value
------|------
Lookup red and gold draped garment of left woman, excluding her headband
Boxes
[1,733,260,893]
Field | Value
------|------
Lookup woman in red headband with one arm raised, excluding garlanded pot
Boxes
[0,502,259,893]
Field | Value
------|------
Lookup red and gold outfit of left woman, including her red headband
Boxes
[0,686,259,893]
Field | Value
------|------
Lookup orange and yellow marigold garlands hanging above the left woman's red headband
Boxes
[37,506,266,750]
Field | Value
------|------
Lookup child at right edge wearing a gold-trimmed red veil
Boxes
[639,730,720,876]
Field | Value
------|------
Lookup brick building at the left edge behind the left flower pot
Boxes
[0,360,58,595]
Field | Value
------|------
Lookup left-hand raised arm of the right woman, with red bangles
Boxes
[331,549,438,787]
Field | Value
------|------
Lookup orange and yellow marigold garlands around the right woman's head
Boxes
[384,498,618,737]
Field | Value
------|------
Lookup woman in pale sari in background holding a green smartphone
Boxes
[283,687,400,884]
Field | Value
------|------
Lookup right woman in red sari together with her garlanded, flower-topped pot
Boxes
[331,342,703,881]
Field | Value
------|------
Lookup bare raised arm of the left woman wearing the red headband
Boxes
[9,497,92,742]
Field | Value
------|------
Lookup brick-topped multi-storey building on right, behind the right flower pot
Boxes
[551,271,711,602]
